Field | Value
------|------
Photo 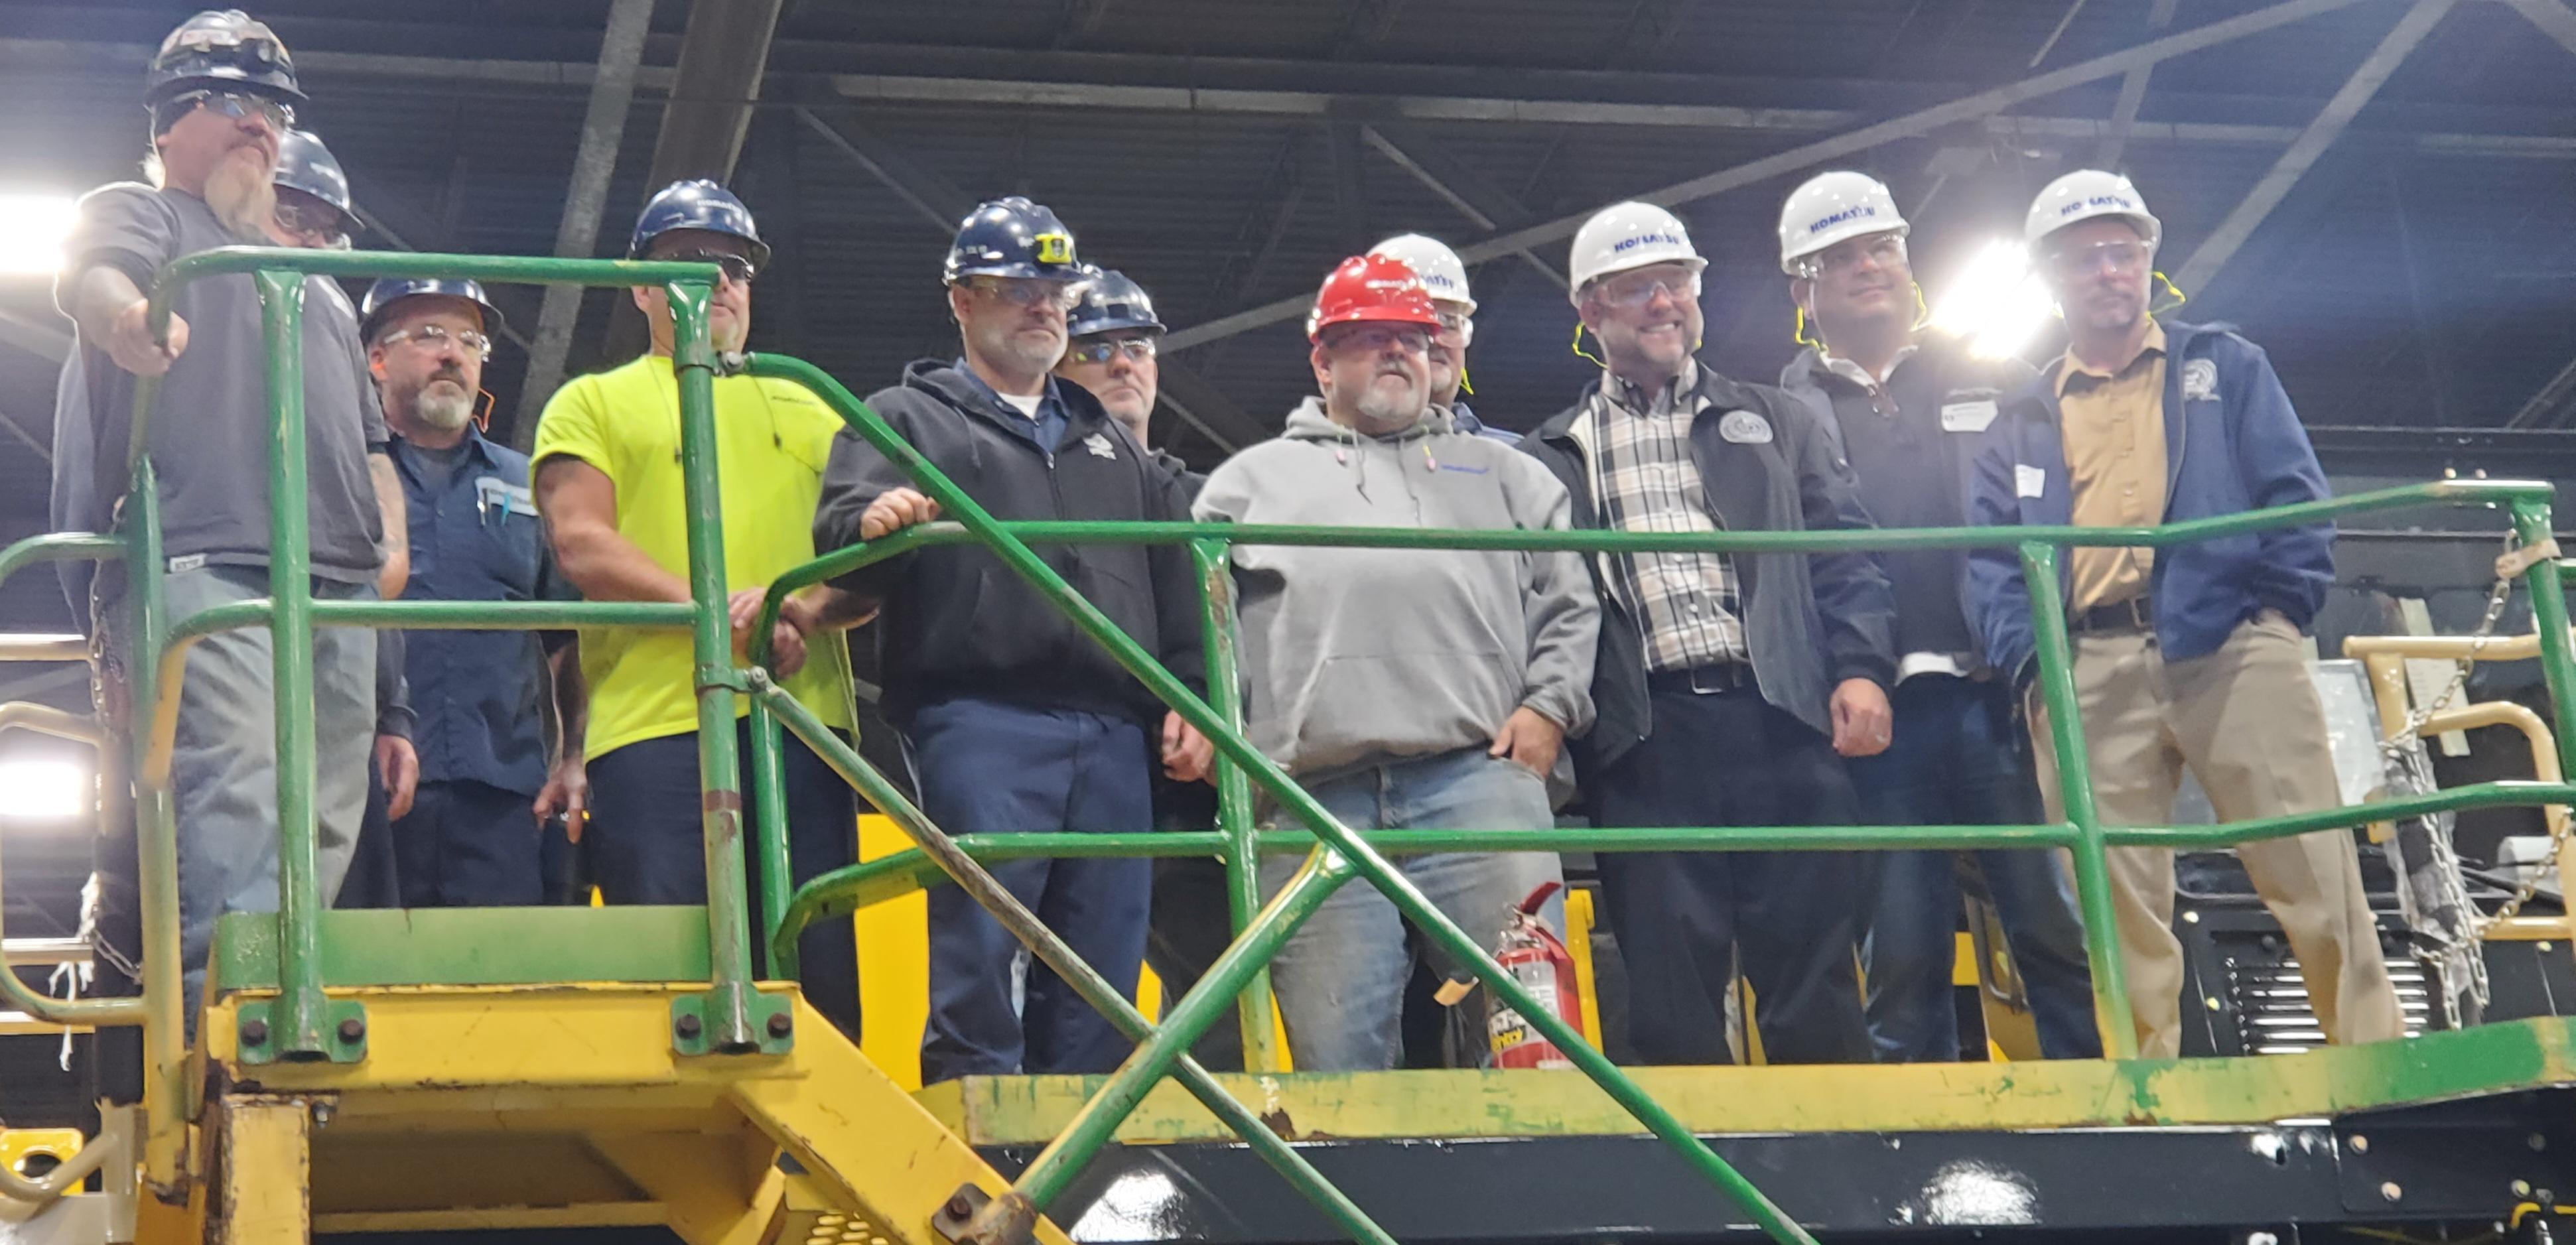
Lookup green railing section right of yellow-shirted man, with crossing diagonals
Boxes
[739,356,2576,1240]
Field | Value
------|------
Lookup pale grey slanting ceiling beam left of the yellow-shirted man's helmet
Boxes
[510,0,651,454]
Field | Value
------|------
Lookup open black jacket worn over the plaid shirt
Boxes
[1520,363,1896,783]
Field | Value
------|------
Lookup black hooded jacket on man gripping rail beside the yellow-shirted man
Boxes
[814,358,1205,727]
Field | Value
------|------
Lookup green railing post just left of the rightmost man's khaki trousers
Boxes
[2022,541,2138,1059]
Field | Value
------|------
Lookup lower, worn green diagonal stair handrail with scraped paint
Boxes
[752,685,1394,1245]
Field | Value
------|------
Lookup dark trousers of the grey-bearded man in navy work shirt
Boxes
[394,779,546,907]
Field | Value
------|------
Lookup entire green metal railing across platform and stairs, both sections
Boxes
[15,247,2576,1242]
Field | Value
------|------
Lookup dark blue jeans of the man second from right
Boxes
[1852,675,2102,1065]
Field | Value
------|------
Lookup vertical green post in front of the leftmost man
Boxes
[255,268,332,1057]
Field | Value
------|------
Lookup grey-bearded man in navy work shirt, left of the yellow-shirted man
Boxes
[364,279,590,907]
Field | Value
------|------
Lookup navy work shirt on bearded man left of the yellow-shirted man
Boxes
[389,428,580,799]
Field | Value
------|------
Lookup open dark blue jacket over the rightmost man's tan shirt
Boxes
[1968,322,2334,678]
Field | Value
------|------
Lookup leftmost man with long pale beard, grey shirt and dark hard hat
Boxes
[54,11,384,1041]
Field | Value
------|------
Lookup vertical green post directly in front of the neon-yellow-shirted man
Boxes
[662,281,760,1052]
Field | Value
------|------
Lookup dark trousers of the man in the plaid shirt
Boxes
[1592,688,1870,1065]
